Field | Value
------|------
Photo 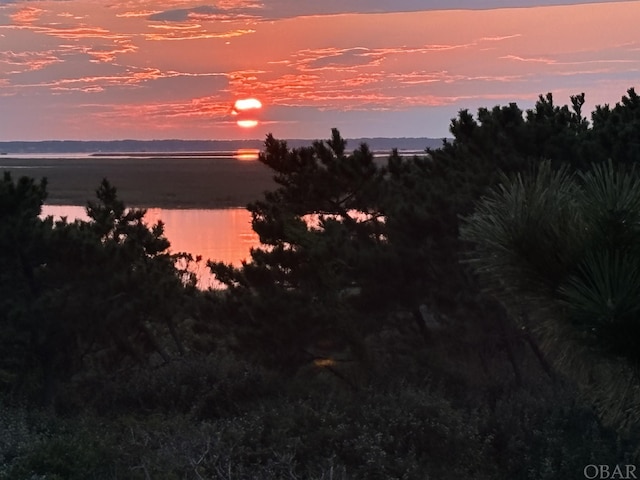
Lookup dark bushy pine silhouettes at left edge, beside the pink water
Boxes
[0,174,190,404]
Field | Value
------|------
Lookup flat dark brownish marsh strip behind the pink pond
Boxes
[0,156,276,208]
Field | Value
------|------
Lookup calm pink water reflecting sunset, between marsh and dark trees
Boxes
[42,205,260,288]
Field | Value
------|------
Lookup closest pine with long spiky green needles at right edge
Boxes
[463,161,640,438]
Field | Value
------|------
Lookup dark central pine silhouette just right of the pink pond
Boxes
[209,129,385,370]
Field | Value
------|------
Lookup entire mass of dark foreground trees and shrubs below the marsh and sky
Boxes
[0,89,640,479]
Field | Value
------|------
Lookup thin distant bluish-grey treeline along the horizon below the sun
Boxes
[0,137,442,154]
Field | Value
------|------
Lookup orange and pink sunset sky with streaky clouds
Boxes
[0,0,640,141]
